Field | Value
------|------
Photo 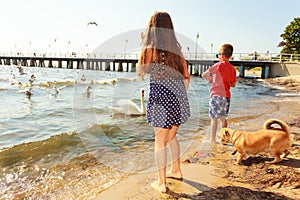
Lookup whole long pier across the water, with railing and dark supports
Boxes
[0,53,300,78]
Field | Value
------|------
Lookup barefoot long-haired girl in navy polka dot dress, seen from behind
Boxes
[137,12,190,192]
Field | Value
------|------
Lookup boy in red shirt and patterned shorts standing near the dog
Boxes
[202,44,236,143]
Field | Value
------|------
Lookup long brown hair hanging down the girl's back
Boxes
[138,11,189,78]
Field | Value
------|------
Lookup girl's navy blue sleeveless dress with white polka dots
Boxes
[147,55,190,128]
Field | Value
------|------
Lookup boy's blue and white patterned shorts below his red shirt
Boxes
[209,96,230,118]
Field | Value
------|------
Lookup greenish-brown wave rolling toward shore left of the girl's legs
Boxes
[0,117,153,167]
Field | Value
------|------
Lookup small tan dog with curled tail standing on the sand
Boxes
[221,119,291,164]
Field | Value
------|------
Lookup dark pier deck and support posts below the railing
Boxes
[0,55,298,78]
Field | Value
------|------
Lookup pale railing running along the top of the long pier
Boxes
[0,52,300,62]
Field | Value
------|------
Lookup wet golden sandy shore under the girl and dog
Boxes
[97,77,300,200]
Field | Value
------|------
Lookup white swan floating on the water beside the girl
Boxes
[108,89,146,116]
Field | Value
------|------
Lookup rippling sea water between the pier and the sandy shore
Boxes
[0,65,298,199]
